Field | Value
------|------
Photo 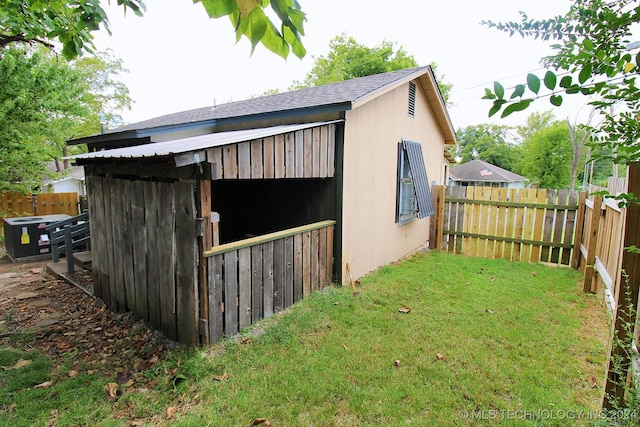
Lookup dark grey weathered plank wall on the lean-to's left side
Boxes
[87,176,199,344]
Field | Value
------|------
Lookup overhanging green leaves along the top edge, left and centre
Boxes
[0,0,306,59]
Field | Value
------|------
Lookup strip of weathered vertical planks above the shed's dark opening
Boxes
[207,124,336,180]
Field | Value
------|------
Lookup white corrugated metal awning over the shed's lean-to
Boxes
[68,120,341,160]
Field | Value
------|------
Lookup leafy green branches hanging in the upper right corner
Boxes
[483,0,640,169]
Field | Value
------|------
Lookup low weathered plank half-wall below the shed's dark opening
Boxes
[205,225,334,343]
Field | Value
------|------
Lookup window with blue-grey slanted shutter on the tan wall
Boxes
[396,140,435,225]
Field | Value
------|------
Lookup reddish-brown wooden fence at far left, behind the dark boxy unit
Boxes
[0,192,80,220]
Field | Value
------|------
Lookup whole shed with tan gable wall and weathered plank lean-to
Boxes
[70,67,455,344]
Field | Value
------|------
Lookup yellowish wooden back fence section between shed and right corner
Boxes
[438,186,579,265]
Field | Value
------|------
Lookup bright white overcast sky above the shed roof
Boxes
[94,0,585,129]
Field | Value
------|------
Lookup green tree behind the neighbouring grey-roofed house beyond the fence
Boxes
[456,124,519,170]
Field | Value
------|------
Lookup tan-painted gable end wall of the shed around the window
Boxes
[342,85,444,284]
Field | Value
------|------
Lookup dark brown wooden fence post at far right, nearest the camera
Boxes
[602,162,640,409]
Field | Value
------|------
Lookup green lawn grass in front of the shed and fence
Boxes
[0,252,607,426]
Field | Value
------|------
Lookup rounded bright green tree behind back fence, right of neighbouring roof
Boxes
[518,122,572,188]
